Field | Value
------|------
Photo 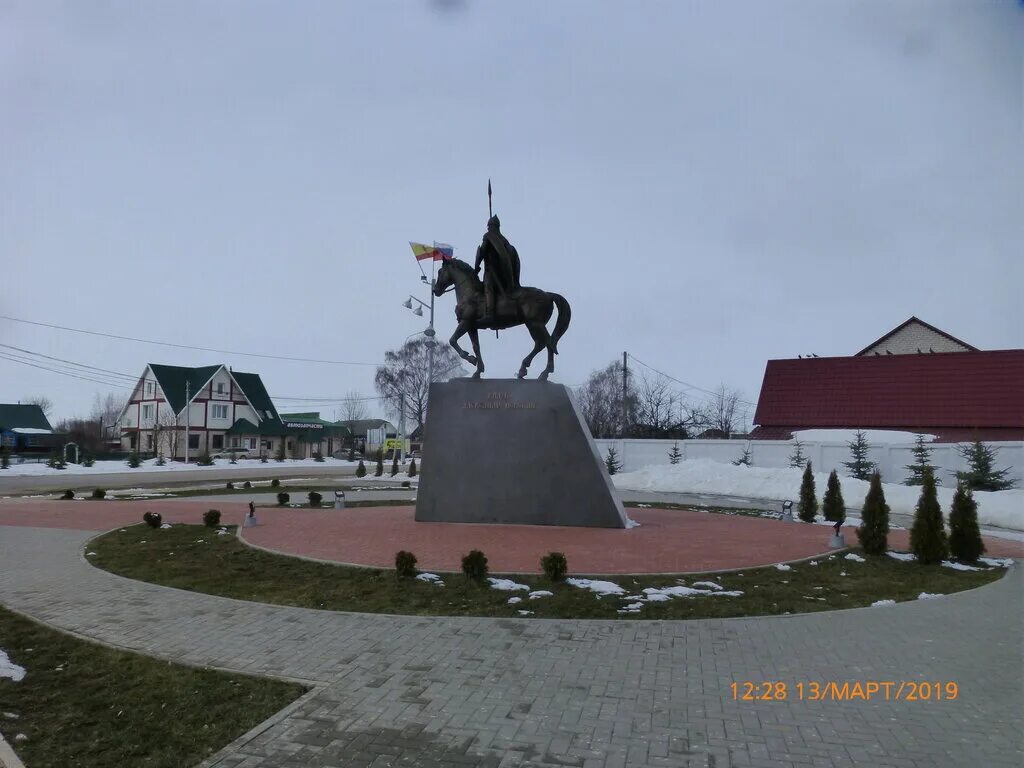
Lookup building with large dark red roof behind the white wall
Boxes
[752,317,1024,442]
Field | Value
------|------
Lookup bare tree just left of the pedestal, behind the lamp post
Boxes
[374,337,466,427]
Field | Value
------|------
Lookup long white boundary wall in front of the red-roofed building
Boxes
[596,439,1024,487]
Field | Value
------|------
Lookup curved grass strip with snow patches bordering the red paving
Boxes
[88,525,1004,618]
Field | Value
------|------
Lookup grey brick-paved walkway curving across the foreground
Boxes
[0,527,1024,768]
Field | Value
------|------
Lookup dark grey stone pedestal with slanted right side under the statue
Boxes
[416,379,627,528]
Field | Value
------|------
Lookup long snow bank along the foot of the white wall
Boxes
[612,459,1024,530]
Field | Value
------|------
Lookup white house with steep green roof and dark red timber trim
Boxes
[118,362,351,459]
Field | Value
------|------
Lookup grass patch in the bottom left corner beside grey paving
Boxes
[0,608,304,768]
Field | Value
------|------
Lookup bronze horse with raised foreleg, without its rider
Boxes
[434,259,571,380]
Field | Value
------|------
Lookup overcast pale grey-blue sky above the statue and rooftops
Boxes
[0,0,1024,418]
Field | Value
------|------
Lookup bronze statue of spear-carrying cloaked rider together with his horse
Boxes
[434,207,571,380]
